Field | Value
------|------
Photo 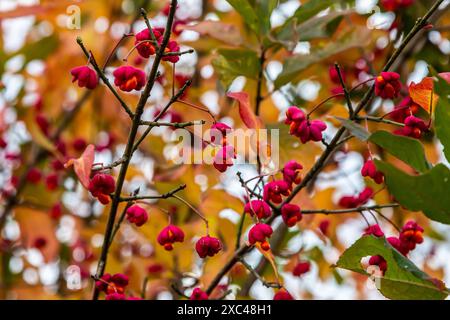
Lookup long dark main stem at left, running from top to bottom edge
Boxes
[92,0,178,300]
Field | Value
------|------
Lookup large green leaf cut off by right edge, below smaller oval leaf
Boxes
[375,160,450,224]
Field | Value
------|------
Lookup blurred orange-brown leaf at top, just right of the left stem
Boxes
[178,20,242,46]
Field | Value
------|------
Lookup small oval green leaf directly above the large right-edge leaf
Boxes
[369,131,431,173]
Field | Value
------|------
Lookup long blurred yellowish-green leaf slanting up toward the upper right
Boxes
[275,28,370,88]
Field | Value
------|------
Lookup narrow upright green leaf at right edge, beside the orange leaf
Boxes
[434,76,450,161]
